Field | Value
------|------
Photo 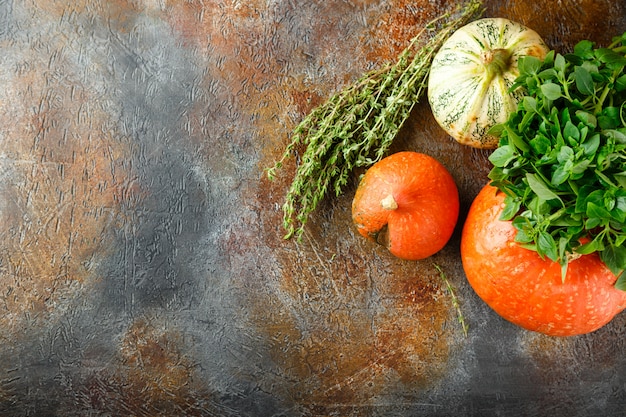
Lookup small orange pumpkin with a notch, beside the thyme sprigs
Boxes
[352,151,459,260]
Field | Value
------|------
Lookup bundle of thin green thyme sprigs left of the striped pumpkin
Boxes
[267,0,483,239]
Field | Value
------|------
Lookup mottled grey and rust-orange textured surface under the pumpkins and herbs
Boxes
[0,0,626,416]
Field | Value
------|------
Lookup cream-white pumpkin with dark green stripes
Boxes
[428,18,548,149]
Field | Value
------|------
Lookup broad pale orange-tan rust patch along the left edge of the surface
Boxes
[0,30,131,330]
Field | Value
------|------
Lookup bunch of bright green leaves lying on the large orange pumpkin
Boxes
[489,33,626,290]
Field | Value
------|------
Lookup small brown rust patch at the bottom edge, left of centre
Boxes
[82,318,208,416]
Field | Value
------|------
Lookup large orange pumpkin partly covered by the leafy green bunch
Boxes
[461,185,626,336]
